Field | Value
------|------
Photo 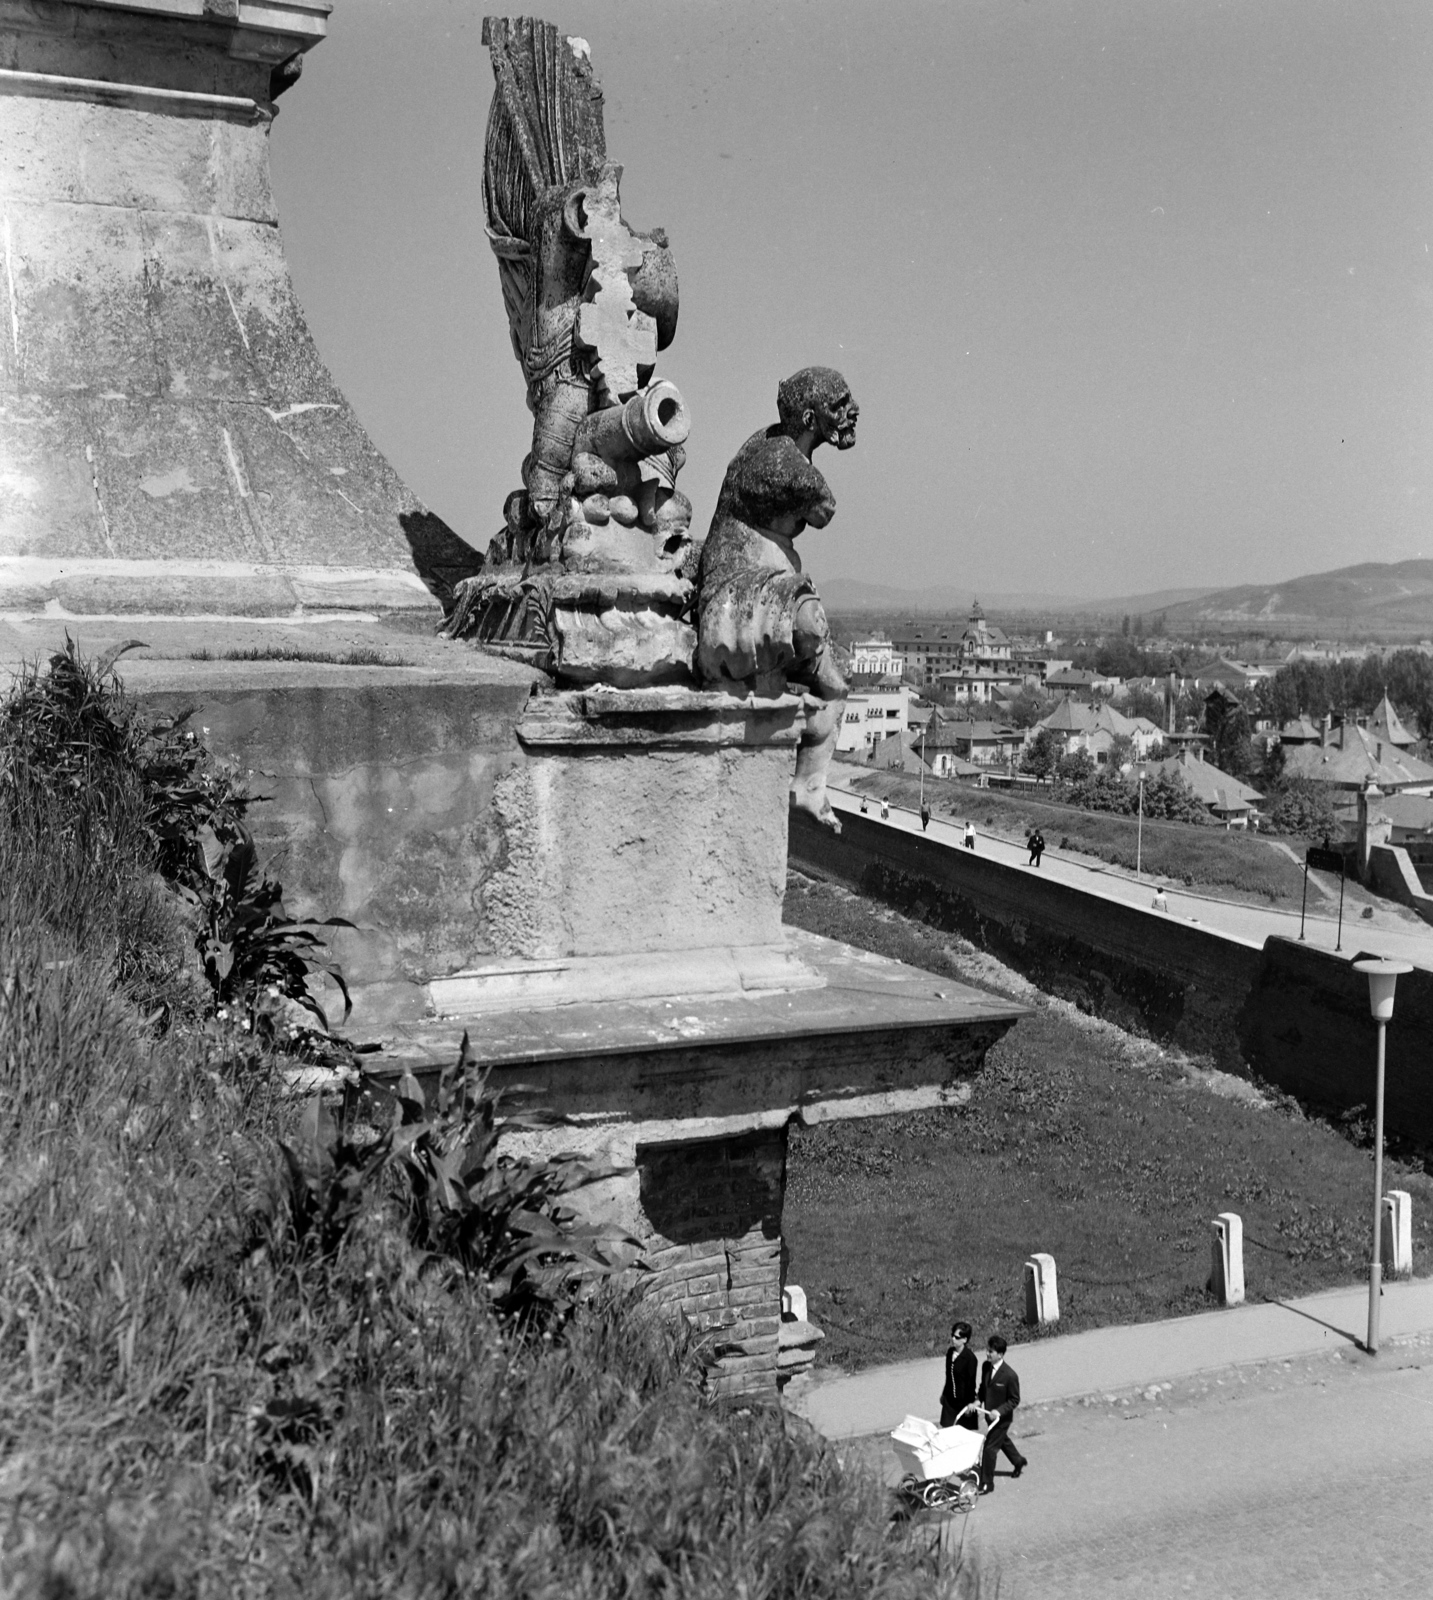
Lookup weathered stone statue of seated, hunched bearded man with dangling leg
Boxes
[697,366,860,832]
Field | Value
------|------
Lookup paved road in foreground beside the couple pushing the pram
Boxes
[927,1346,1433,1600]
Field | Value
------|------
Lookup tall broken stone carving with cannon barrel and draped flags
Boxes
[445,18,696,686]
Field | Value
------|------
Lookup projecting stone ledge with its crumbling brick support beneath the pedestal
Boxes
[374,930,1025,1395]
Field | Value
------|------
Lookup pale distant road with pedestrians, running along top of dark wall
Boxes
[832,787,1433,971]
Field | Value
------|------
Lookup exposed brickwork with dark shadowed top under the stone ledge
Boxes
[637,1128,787,1398]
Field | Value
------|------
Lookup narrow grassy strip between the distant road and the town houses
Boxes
[835,765,1307,909]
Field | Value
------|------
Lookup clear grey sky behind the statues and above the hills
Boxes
[272,0,1433,598]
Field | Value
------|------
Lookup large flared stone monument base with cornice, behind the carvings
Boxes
[0,0,460,621]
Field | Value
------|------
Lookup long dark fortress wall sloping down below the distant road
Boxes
[790,813,1433,1144]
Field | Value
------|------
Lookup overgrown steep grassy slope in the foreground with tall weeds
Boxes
[0,649,969,1600]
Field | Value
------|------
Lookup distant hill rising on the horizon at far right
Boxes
[1128,560,1433,637]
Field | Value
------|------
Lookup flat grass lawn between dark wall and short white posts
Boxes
[785,875,1433,1366]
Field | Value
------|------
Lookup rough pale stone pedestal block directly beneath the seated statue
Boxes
[485,688,803,960]
